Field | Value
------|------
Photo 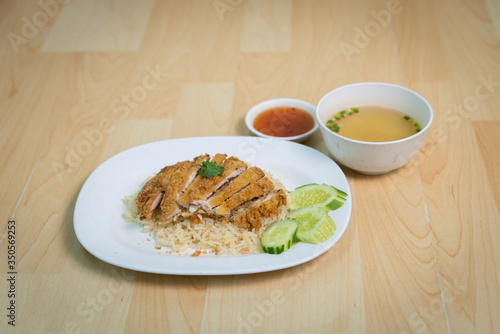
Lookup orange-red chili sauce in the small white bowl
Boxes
[253,107,314,137]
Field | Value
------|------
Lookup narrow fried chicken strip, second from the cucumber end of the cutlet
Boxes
[215,177,274,216]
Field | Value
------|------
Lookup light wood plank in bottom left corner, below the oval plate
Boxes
[1,270,136,333]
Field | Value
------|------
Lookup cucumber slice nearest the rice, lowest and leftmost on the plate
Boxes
[260,218,298,254]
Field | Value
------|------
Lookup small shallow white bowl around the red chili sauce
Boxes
[245,98,318,142]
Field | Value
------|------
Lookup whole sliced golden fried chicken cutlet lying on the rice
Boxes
[136,154,287,230]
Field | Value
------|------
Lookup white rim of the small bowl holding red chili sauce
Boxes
[245,97,319,141]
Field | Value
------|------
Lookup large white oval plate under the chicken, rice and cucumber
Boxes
[73,137,352,275]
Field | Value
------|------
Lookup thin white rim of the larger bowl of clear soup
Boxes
[316,81,434,145]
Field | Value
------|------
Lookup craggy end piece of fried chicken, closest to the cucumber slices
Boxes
[230,189,287,230]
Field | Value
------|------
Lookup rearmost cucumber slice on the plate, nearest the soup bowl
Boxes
[289,183,347,210]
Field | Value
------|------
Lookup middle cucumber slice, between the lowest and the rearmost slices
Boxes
[288,206,337,245]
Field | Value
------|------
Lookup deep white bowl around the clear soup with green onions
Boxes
[316,82,433,175]
